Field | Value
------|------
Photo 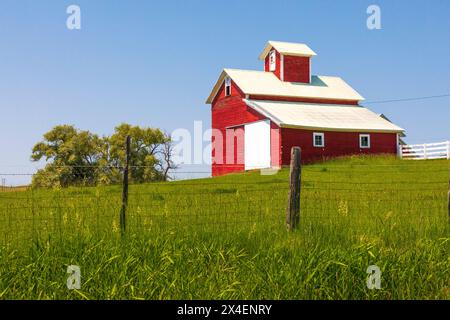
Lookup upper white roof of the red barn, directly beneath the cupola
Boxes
[206,69,364,103]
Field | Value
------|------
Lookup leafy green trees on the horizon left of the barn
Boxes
[31,123,176,187]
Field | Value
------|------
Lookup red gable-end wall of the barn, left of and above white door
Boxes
[211,81,265,176]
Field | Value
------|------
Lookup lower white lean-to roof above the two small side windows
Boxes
[244,99,404,133]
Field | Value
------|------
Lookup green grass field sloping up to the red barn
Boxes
[0,157,450,299]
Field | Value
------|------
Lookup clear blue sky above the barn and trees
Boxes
[0,0,450,183]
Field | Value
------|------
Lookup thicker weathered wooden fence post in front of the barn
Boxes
[286,147,302,230]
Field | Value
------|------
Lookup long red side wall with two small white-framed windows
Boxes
[281,128,397,165]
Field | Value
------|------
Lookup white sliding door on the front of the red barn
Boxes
[244,120,271,170]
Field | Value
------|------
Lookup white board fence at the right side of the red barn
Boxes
[400,141,450,160]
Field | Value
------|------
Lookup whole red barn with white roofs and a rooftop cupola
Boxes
[206,41,404,176]
